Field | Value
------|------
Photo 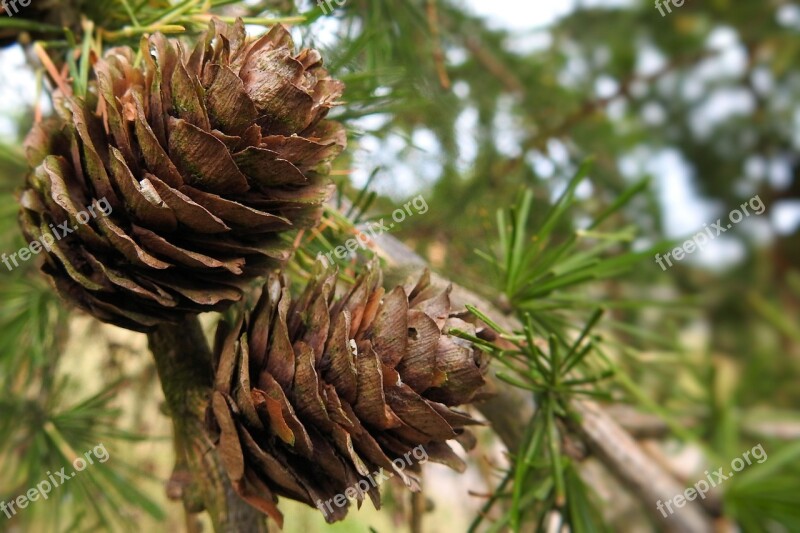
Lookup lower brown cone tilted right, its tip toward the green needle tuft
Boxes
[209,267,484,523]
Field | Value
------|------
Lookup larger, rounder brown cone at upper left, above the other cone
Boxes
[20,21,346,331]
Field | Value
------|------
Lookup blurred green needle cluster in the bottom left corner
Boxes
[0,380,165,531]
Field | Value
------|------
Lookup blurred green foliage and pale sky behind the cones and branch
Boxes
[0,0,800,531]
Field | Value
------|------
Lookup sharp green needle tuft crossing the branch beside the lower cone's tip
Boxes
[452,308,613,531]
